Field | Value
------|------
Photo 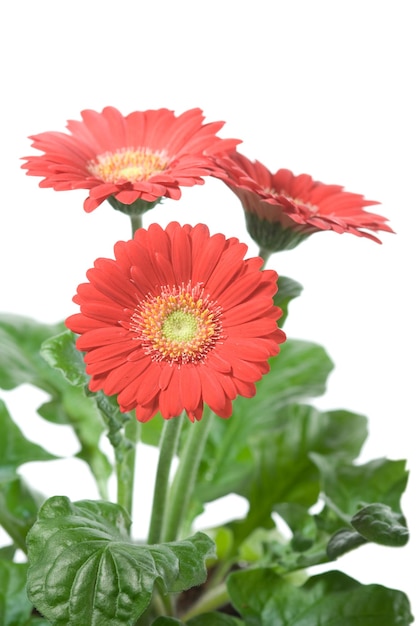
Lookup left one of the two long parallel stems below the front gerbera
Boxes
[148,417,183,544]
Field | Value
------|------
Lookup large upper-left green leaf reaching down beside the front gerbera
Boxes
[0,315,111,497]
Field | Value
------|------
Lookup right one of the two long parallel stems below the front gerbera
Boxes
[163,414,213,541]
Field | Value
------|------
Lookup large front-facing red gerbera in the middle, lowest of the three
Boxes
[66,222,285,422]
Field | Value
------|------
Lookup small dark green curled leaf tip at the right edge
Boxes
[351,503,409,547]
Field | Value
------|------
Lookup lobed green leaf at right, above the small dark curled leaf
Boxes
[228,405,366,543]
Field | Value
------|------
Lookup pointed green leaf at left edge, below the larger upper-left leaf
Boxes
[0,400,58,480]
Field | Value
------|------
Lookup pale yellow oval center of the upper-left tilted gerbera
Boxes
[87,148,169,183]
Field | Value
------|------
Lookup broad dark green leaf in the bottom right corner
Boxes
[227,568,413,626]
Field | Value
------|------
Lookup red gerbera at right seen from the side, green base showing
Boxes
[216,152,393,252]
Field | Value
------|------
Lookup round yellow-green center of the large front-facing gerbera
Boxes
[131,282,222,364]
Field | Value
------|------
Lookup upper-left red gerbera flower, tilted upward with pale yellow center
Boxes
[22,107,240,212]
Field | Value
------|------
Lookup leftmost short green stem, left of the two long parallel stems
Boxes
[116,416,139,516]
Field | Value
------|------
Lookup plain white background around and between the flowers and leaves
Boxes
[0,0,419,614]
